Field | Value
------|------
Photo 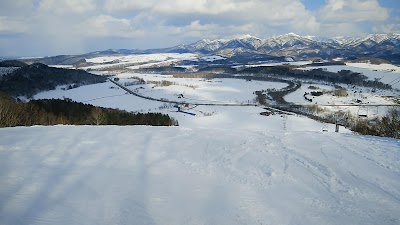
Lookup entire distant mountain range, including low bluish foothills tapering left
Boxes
[17,33,400,64]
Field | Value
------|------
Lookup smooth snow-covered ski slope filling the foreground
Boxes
[0,126,400,225]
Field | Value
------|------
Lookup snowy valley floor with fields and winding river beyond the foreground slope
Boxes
[26,53,400,130]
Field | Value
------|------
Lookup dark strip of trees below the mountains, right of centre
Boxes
[239,66,391,89]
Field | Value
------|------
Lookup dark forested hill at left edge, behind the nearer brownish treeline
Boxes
[0,63,107,97]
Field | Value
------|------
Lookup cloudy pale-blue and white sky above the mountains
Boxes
[0,0,400,56]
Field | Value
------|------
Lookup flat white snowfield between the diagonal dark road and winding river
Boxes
[122,73,287,103]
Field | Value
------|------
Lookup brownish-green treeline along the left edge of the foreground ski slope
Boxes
[0,94,178,127]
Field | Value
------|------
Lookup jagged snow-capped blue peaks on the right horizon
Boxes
[168,33,400,57]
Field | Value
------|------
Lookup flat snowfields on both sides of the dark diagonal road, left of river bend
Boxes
[34,73,287,111]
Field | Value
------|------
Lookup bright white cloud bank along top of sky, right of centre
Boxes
[105,0,320,37]
